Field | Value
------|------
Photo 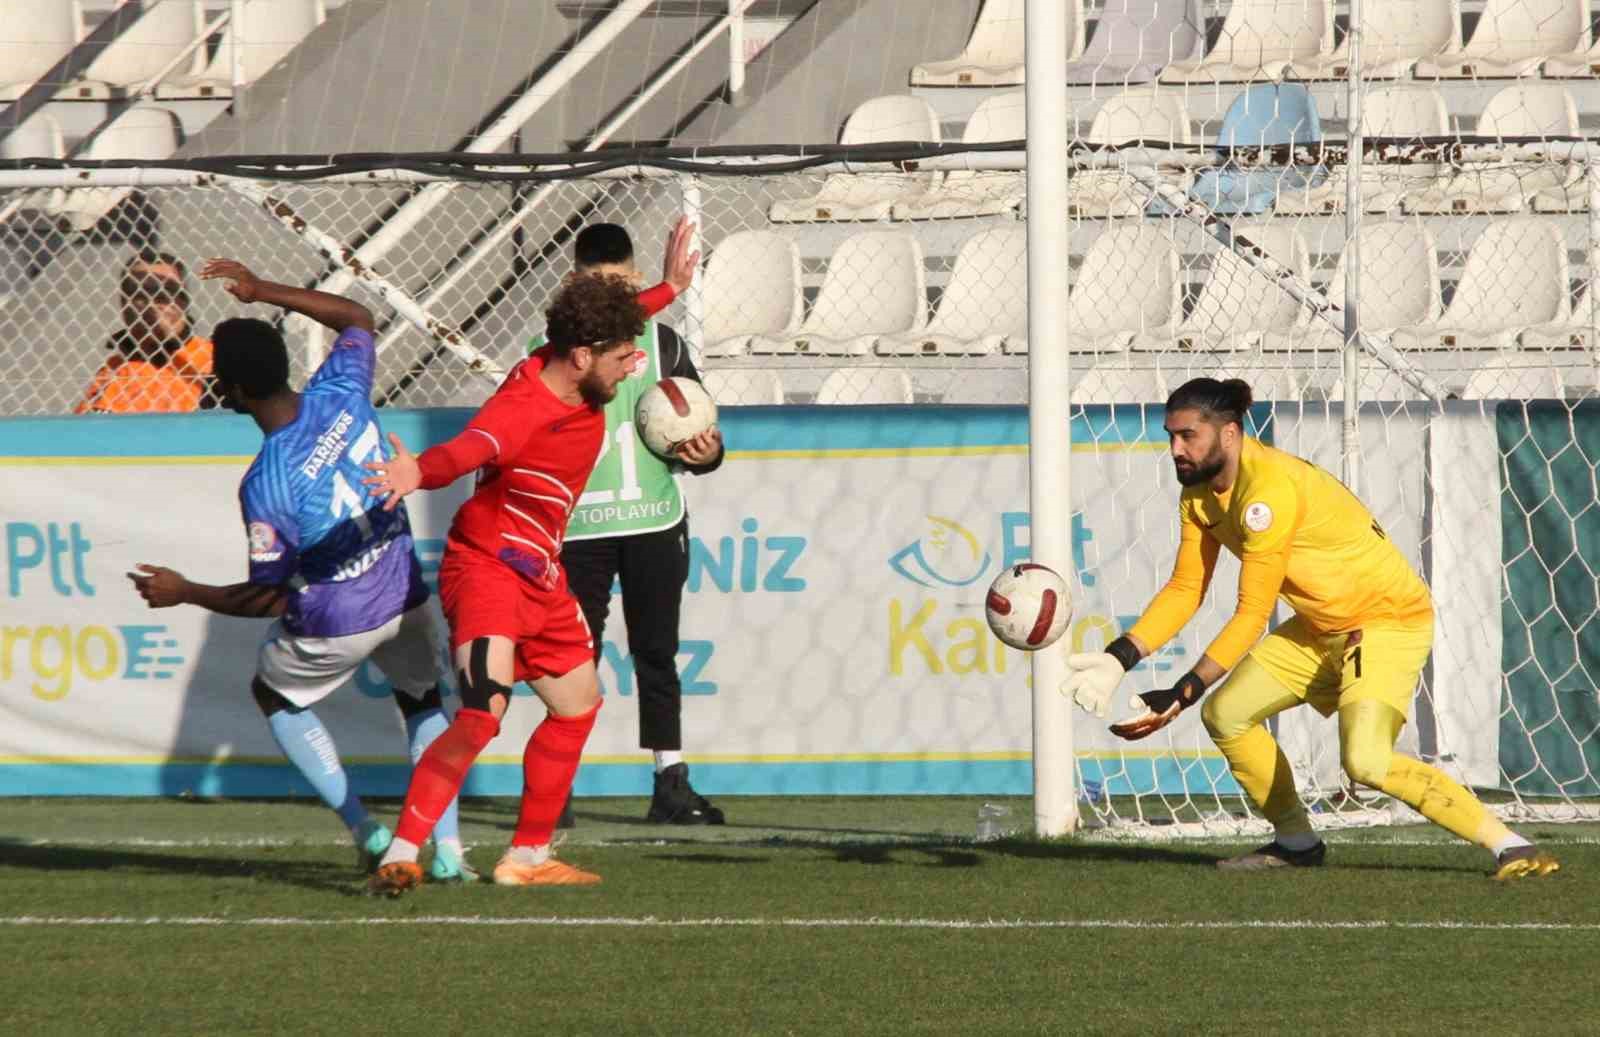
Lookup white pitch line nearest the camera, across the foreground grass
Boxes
[0,915,1600,933]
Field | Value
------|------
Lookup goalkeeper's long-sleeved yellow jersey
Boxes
[1128,438,1434,669]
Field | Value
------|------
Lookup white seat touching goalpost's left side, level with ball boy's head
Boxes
[877,227,1027,357]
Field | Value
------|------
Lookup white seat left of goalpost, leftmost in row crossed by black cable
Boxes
[770,94,939,222]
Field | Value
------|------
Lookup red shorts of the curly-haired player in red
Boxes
[438,547,595,680]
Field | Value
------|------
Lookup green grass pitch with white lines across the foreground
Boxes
[0,797,1600,1037]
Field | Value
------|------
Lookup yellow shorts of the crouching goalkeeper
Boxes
[1248,616,1434,717]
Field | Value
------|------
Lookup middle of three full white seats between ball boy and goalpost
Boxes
[750,230,928,357]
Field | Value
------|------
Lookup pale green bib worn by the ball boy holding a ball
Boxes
[528,320,683,541]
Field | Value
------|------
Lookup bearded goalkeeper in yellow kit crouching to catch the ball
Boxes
[1061,378,1560,880]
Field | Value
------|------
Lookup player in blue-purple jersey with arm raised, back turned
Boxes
[130,259,477,880]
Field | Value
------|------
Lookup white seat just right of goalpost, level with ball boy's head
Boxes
[1056,221,1184,354]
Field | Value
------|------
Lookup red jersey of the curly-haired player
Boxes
[418,349,605,589]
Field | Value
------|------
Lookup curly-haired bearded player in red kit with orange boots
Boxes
[366,277,645,896]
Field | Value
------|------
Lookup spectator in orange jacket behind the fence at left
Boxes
[74,248,214,414]
